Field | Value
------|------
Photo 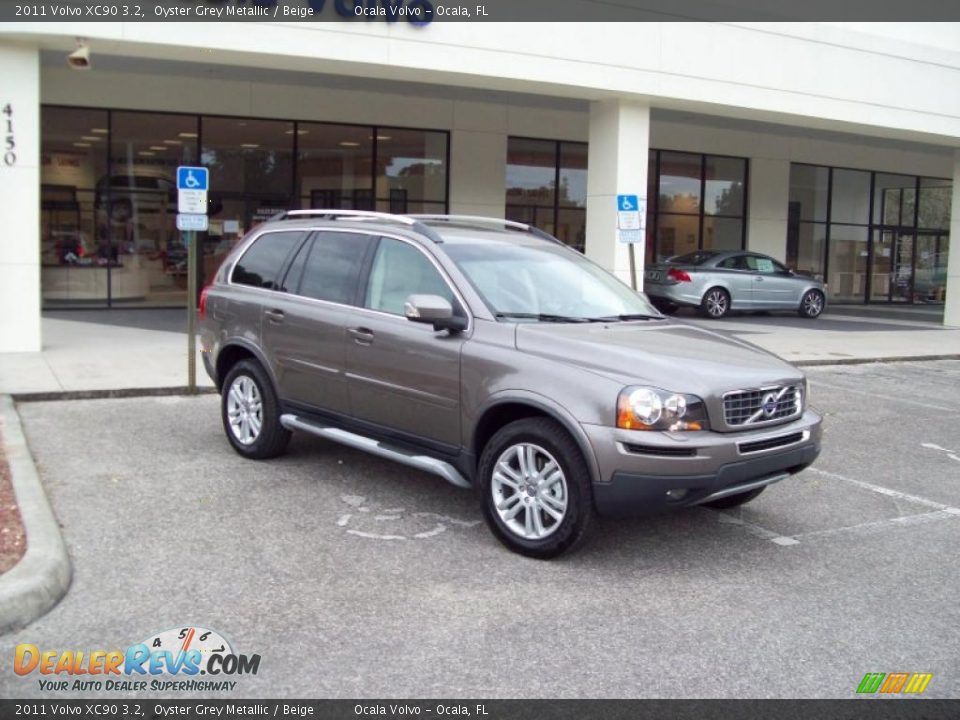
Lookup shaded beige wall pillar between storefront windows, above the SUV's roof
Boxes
[450,101,507,218]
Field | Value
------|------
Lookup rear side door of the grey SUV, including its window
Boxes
[263,230,376,415]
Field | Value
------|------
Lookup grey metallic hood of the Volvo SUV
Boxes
[516,320,803,398]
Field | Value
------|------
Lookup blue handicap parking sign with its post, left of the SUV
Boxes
[177,166,210,394]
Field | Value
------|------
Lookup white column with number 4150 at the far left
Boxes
[0,42,40,352]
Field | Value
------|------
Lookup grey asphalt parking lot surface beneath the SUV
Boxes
[0,361,960,698]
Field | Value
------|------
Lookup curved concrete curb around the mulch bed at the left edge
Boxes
[0,395,73,633]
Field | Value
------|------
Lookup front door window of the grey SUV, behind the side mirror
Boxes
[364,238,454,315]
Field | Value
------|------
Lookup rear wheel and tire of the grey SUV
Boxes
[220,360,290,460]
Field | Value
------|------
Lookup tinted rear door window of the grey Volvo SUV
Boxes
[296,232,373,305]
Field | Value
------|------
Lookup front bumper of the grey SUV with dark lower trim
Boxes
[585,410,821,516]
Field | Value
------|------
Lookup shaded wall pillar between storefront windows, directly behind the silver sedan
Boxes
[747,158,790,262]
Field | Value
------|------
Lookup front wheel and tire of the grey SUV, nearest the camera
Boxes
[477,418,594,560]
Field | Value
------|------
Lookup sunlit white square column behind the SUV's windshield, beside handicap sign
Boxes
[586,100,650,290]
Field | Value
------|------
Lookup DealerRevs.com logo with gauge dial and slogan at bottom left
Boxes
[13,626,260,692]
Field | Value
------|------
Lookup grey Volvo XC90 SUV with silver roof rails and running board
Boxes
[200,210,821,558]
